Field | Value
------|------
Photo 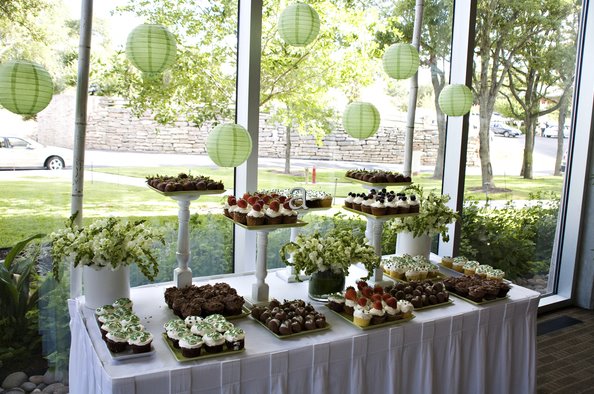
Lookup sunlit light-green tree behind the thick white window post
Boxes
[95,0,378,171]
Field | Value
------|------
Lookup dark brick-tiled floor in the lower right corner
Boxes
[536,308,594,394]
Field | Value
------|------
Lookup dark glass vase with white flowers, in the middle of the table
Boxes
[280,228,380,301]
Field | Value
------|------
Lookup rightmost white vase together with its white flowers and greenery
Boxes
[390,185,459,258]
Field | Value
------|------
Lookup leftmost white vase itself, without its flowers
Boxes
[83,266,130,309]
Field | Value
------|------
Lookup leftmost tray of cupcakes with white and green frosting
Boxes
[95,298,153,359]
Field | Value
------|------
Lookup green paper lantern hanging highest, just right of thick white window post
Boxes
[278,3,320,47]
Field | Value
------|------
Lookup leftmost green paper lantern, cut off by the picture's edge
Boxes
[0,60,54,115]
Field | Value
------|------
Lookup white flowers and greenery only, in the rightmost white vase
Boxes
[390,185,459,242]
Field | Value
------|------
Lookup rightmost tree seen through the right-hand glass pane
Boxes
[502,0,577,179]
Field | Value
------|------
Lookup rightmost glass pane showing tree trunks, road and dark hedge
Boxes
[460,1,580,294]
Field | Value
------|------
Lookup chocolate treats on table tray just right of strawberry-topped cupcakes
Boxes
[384,279,451,310]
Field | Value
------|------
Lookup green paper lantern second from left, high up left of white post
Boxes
[126,24,177,74]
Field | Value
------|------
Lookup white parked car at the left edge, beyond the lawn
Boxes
[0,136,72,170]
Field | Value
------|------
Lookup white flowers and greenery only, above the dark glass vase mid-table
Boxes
[280,229,380,280]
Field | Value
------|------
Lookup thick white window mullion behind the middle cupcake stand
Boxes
[233,0,265,272]
